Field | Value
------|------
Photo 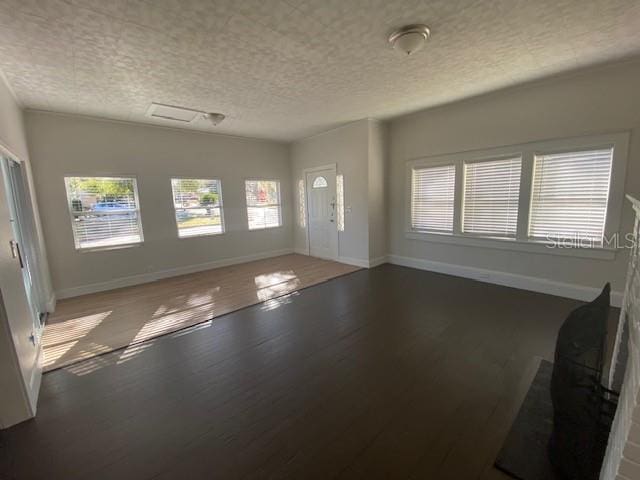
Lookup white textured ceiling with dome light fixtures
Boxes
[0,0,640,140]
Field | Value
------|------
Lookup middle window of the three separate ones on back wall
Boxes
[171,178,224,238]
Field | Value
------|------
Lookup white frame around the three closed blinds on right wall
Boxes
[405,132,629,260]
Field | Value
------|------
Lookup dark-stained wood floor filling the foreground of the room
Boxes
[0,265,620,480]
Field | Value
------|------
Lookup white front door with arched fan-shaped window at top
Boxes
[306,168,338,260]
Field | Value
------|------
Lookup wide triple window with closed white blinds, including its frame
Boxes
[405,132,629,260]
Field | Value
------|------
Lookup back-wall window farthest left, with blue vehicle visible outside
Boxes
[65,177,143,250]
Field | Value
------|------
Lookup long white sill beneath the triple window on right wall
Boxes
[405,231,616,260]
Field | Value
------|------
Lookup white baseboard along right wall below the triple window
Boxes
[387,255,623,307]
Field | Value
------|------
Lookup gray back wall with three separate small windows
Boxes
[26,112,292,296]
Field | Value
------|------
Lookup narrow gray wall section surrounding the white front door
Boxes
[291,119,370,262]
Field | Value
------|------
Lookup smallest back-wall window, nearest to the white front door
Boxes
[245,180,282,230]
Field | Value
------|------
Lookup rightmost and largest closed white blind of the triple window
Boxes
[529,148,613,243]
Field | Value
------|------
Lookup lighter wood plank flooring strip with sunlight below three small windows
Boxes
[42,255,358,371]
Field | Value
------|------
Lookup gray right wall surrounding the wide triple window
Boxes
[388,61,640,290]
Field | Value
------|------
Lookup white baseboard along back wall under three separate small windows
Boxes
[56,248,293,299]
